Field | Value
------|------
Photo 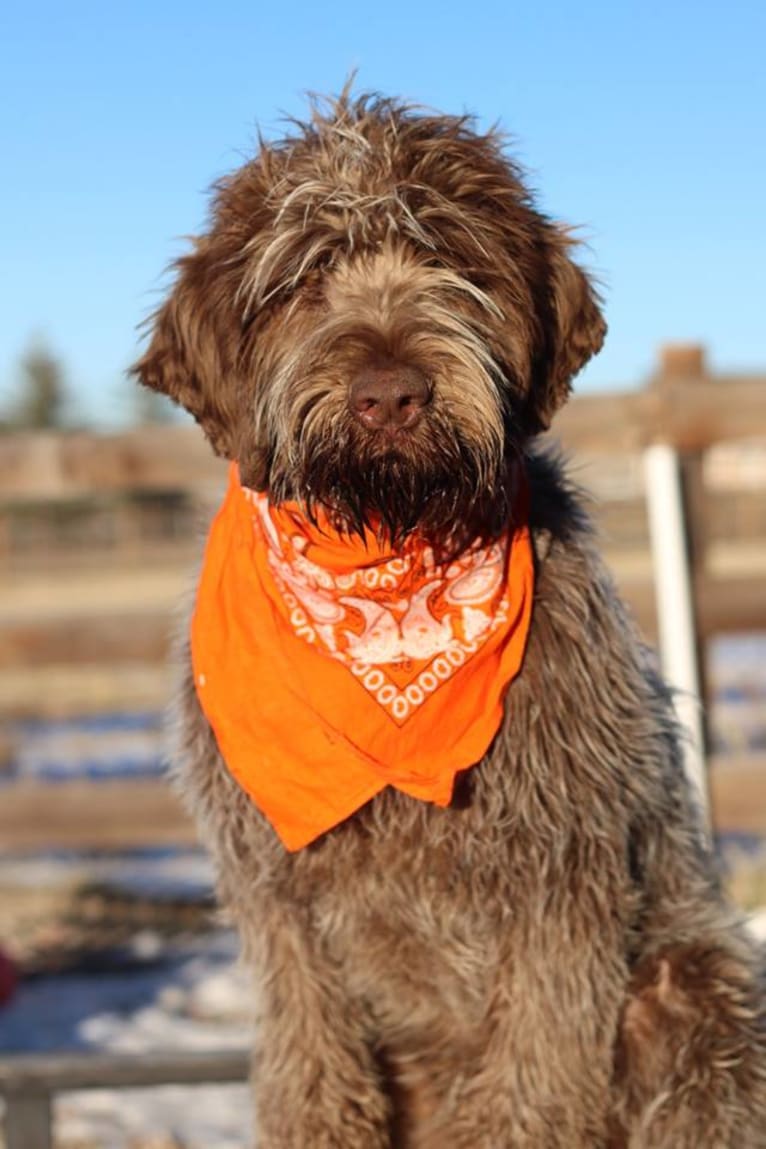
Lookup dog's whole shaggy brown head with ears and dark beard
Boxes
[134,98,605,545]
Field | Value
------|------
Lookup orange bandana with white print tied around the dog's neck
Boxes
[192,464,533,850]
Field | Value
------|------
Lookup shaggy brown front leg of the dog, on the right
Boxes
[416,919,620,1149]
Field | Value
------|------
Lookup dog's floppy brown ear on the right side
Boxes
[527,228,606,432]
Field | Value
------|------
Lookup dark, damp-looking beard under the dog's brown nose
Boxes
[269,412,517,558]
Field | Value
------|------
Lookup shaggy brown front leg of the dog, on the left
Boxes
[245,907,390,1149]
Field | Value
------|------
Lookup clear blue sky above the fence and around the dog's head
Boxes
[0,0,766,423]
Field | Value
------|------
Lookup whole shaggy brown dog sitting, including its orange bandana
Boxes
[133,91,766,1149]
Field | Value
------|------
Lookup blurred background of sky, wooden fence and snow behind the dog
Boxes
[0,0,766,1149]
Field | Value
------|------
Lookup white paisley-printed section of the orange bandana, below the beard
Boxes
[247,491,508,725]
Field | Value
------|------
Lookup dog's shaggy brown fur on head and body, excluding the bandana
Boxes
[136,97,766,1149]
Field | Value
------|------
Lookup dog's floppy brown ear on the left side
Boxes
[131,238,271,487]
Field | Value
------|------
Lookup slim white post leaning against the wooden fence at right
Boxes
[644,444,710,824]
